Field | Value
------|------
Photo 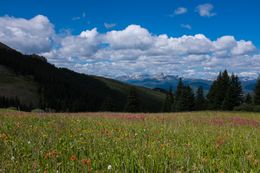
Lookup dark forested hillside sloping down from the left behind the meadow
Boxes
[0,44,164,112]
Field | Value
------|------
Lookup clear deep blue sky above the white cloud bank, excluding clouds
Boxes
[0,0,260,47]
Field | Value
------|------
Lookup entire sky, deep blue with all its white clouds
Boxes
[0,0,260,78]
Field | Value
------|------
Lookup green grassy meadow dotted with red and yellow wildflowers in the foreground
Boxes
[0,110,260,173]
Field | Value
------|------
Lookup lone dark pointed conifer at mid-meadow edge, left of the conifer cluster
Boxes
[125,87,140,112]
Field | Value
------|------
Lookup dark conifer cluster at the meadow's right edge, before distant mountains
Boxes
[162,70,260,112]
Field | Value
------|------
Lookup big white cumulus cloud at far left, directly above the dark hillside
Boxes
[0,15,55,53]
